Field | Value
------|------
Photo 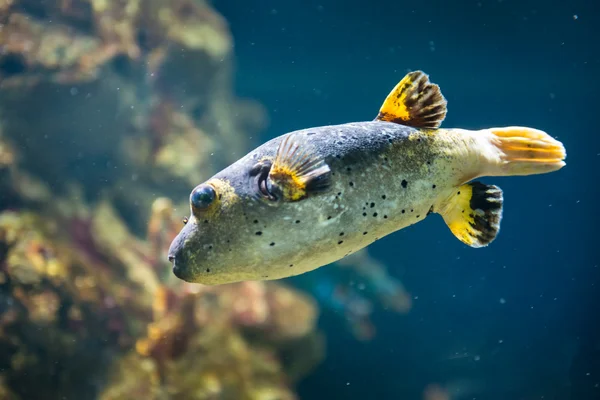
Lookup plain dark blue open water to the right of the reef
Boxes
[215,0,600,400]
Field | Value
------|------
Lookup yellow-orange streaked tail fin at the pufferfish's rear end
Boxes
[484,126,567,176]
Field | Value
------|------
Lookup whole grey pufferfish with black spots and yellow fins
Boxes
[168,71,566,285]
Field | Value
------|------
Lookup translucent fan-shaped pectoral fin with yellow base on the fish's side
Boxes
[269,134,331,201]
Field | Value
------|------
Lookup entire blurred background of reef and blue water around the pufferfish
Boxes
[0,0,600,400]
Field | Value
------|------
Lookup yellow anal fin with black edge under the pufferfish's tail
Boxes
[439,181,503,247]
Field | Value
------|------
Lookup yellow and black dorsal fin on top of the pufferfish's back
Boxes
[376,71,446,129]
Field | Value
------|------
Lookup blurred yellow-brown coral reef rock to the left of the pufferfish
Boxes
[0,0,324,400]
